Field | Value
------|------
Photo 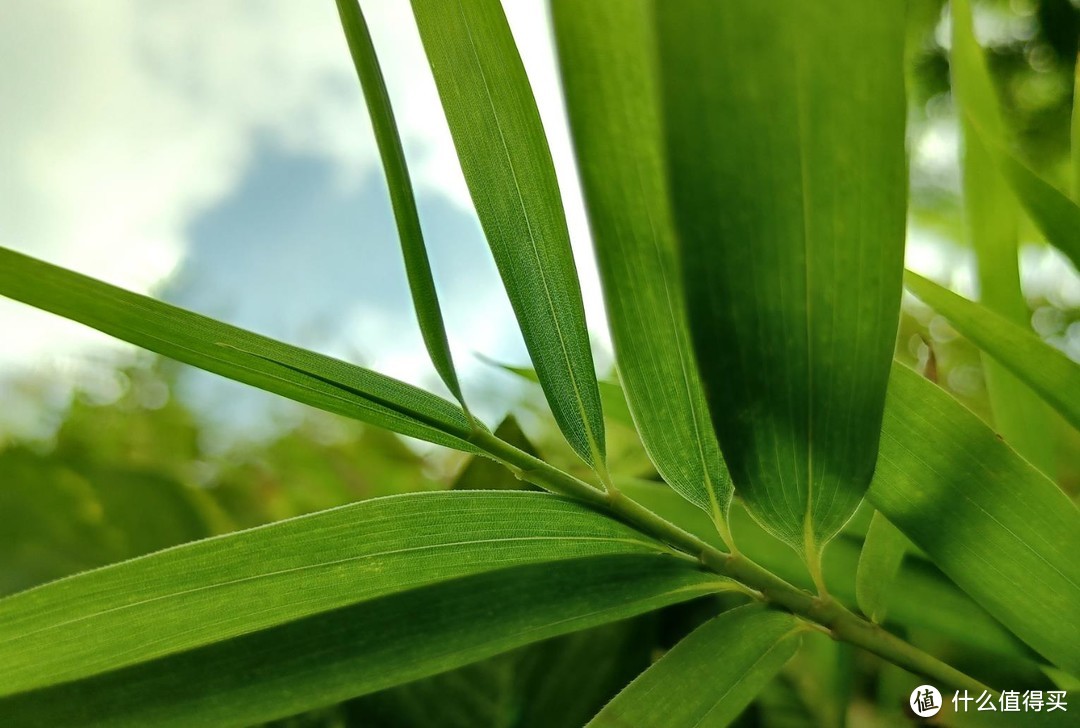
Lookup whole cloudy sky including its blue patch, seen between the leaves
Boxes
[0,0,1080,442]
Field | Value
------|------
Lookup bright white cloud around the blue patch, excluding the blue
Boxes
[0,0,606,436]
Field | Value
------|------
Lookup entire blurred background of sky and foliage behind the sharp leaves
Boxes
[0,0,1080,722]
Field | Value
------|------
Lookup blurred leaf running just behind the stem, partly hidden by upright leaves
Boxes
[616,473,1032,658]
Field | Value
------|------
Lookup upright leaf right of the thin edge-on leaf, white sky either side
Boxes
[413,0,604,469]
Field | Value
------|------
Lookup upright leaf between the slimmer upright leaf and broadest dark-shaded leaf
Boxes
[552,0,732,530]
